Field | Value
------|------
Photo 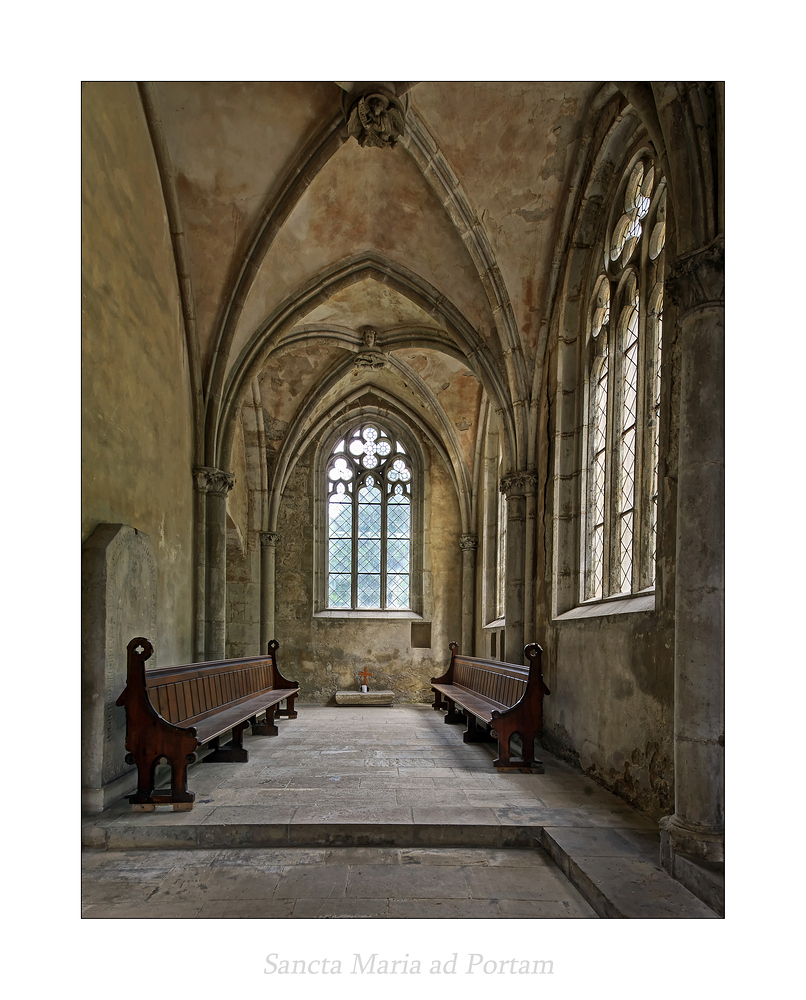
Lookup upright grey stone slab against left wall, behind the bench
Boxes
[81,524,157,813]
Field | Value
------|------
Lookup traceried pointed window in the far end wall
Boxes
[326,423,413,611]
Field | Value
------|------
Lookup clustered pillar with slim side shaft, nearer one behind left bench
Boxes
[193,468,235,660]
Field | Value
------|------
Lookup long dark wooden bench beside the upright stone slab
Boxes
[116,637,299,812]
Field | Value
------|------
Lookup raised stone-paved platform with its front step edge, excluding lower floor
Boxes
[82,708,717,919]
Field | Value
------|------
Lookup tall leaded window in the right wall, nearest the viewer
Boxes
[581,154,666,601]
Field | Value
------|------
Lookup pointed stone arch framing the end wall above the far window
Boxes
[268,383,471,531]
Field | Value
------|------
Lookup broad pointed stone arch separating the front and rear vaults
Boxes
[214,253,518,478]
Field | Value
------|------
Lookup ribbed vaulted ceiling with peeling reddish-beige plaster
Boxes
[145,82,601,473]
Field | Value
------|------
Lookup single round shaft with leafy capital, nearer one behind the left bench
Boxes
[196,469,235,660]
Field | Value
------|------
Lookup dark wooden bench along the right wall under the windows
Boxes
[431,642,551,774]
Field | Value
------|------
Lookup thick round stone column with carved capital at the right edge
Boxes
[661,238,725,871]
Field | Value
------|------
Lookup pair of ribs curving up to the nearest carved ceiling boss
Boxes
[200,103,528,466]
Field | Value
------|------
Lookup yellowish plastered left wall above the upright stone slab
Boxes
[82,83,193,666]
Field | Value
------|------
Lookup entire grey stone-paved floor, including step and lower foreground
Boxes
[83,704,716,918]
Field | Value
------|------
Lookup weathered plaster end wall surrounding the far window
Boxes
[275,449,461,704]
